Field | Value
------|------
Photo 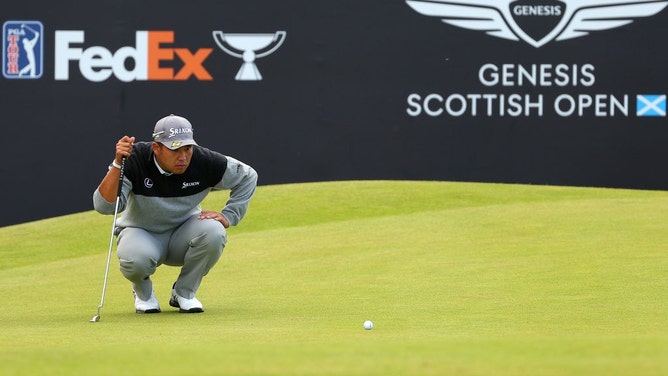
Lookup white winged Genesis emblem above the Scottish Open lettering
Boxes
[406,0,668,48]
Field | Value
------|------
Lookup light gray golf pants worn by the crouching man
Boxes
[117,215,227,300]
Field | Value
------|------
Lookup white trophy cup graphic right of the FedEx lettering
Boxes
[213,31,285,81]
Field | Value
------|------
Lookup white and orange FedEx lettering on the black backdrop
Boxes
[55,30,213,82]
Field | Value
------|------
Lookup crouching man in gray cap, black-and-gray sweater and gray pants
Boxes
[93,115,257,313]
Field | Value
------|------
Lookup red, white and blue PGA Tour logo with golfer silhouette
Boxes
[2,21,44,79]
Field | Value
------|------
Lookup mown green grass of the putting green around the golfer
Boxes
[0,181,668,376]
